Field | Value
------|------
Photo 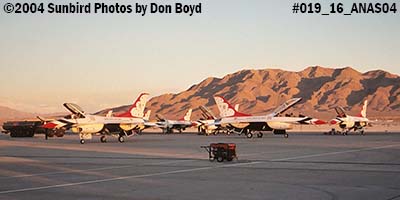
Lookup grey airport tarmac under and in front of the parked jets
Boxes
[0,132,400,200]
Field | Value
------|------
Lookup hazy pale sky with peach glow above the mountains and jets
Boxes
[0,0,400,112]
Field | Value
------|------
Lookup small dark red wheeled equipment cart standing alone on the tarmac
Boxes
[201,143,238,162]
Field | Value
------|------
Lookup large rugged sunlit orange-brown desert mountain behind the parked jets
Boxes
[93,66,400,119]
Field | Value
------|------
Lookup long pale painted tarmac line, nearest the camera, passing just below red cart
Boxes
[0,162,262,194]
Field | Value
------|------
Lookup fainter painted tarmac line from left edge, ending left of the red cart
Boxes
[0,160,194,180]
